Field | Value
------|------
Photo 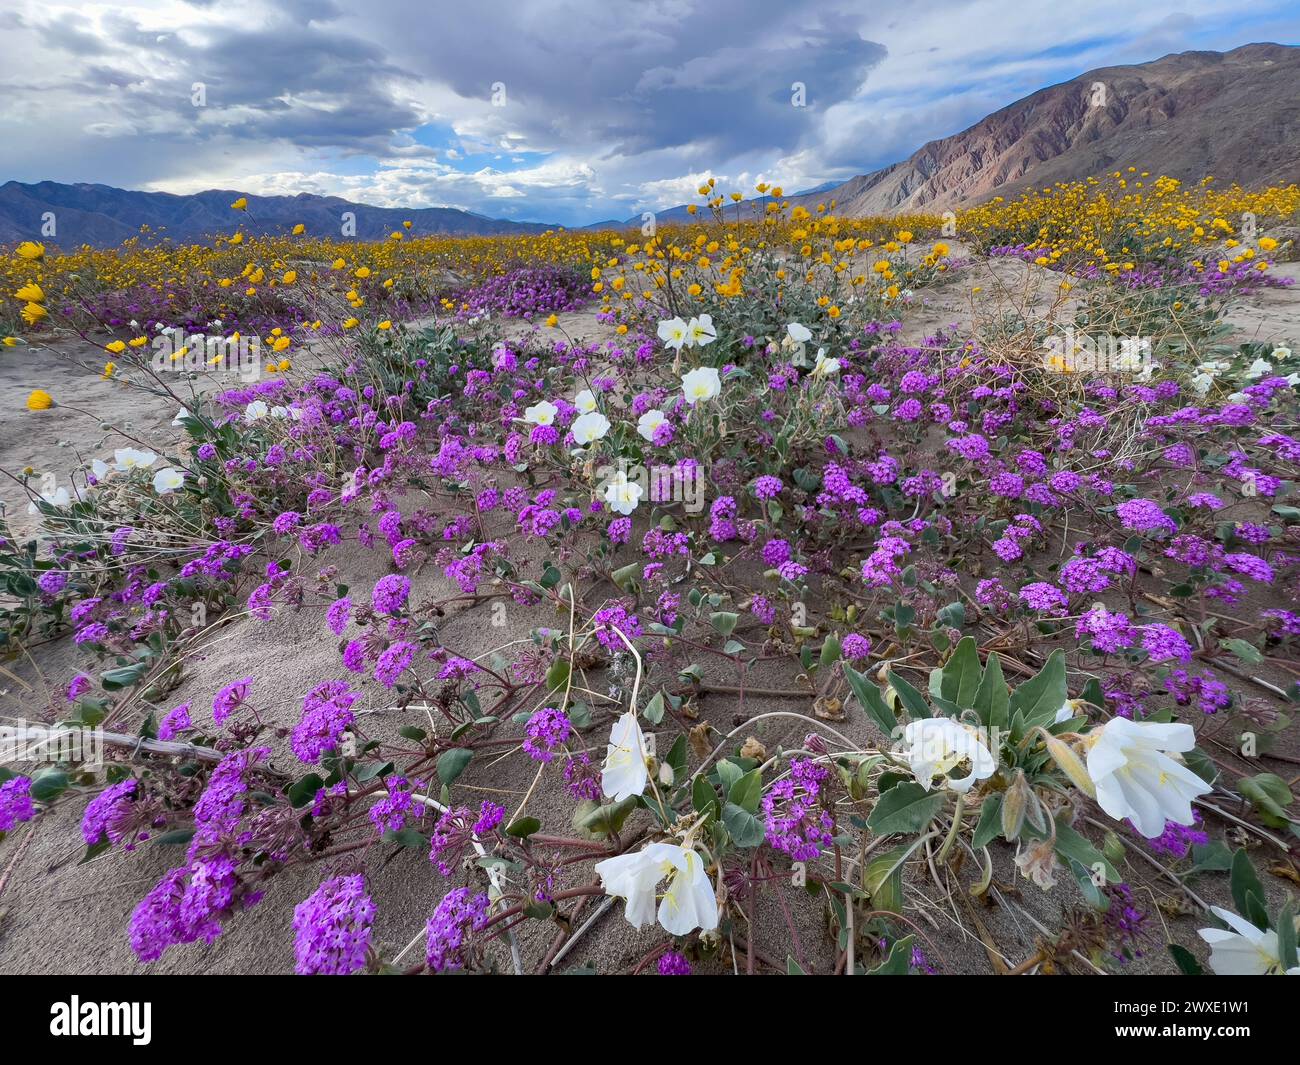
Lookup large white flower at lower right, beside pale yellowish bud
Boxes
[1088,718,1213,839]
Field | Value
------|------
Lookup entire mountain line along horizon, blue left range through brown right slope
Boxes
[0,44,1300,247]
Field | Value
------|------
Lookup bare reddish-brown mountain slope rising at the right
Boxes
[798,44,1300,215]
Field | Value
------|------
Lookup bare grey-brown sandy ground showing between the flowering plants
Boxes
[0,253,1300,974]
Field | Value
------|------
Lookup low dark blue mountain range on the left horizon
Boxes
[0,181,556,248]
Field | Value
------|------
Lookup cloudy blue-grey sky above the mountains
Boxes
[0,0,1300,225]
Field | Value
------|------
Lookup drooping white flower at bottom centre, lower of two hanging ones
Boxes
[595,843,718,935]
